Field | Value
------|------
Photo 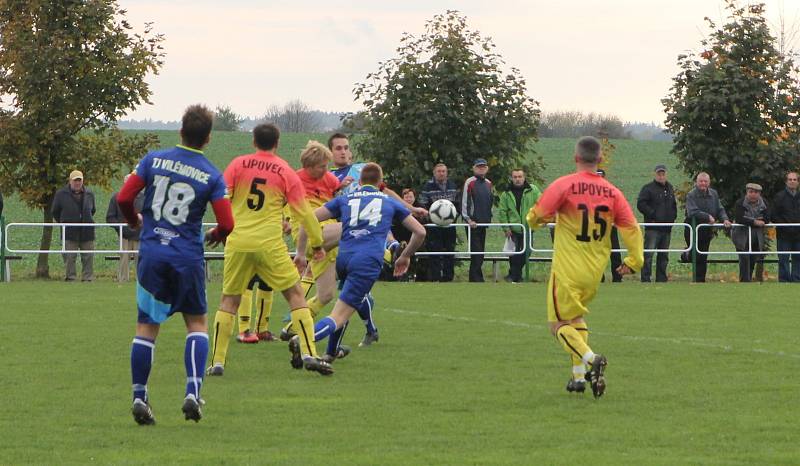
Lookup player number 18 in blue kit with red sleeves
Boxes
[117,105,233,425]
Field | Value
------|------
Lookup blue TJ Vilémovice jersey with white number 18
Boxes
[134,146,226,260]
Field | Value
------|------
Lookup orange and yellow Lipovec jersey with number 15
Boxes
[527,172,644,288]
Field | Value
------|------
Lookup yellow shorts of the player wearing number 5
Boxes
[222,242,300,295]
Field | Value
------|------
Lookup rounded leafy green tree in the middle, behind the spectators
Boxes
[354,11,543,189]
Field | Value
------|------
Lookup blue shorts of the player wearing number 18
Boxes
[136,255,206,324]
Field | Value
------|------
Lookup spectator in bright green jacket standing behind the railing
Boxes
[498,169,542,283]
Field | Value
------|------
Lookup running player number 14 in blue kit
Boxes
[314,163,425,359]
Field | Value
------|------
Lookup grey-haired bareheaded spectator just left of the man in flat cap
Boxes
[686,172,731,283]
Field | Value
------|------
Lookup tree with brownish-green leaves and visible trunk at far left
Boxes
[0,0,163,277]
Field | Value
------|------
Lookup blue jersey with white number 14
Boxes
[325,185,410,258]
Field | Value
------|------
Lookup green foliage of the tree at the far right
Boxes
[662,0,800,209]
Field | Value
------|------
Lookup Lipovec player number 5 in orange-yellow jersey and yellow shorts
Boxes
[208,124,333,375]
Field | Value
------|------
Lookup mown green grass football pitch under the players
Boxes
[0,282,800,465]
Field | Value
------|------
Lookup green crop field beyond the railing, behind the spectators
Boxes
[4,131,756,280]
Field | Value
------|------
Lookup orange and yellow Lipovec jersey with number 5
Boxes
[223,151,322,252]
